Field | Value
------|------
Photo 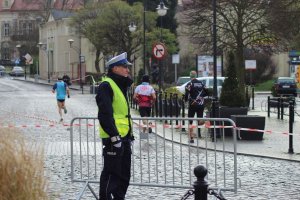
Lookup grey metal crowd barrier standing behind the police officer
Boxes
[70,117,238,199]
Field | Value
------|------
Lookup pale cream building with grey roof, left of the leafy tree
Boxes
[39,9,103,82]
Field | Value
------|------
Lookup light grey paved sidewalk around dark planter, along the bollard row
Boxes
[132,109,300,161]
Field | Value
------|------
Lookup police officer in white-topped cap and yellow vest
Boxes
[96,53,133,200]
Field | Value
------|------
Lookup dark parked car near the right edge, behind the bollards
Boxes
[272,77,297,97]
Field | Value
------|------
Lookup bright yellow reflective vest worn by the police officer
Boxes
[99,77,132,138]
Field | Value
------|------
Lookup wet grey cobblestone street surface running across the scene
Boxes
[0,78,300,200]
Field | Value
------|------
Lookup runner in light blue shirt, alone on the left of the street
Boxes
[52,77,70,122]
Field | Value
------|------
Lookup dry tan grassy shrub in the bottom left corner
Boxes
[0,128,48,200]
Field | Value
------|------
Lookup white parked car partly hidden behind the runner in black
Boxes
[176,76,225,96]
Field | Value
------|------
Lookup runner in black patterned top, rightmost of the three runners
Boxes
[185,71,208,143]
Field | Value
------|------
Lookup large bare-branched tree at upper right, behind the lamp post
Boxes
[185,0,299,85]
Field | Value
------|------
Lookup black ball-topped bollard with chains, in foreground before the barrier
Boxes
[193,165,208,200]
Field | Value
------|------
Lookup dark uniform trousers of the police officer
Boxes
[99,139,131,200]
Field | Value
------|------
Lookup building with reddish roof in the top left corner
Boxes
[0,0,46,63]
